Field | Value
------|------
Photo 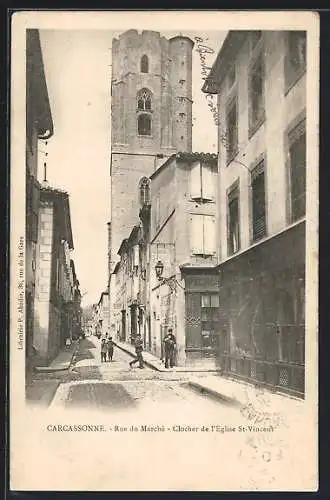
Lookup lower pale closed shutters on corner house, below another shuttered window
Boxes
[191,214,216,255]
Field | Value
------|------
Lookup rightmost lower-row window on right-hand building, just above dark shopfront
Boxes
[289,121,306,222]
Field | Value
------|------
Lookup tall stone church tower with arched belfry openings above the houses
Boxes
[109,30,193,275]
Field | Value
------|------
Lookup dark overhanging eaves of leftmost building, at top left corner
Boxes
[26,29,54,139]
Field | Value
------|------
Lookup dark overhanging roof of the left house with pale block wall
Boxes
[40,184,74,250]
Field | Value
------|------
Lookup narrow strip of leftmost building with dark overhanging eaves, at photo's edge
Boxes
[25,29,54,372]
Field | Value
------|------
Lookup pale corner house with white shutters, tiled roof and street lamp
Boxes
[149,153,218,367]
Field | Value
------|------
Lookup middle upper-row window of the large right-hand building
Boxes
[249,54,265,135]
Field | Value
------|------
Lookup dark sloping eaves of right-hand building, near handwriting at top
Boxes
[202,30,250,94]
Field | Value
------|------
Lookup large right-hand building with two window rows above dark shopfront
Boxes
[203,31,306,395]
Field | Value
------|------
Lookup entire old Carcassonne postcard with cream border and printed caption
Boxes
[10,10,319,491]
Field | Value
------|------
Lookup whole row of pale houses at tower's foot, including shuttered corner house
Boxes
[114,153,219,367]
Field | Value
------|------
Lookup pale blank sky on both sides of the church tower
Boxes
[39,29,226,306]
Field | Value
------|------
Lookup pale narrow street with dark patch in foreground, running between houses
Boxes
[37,336,237,418]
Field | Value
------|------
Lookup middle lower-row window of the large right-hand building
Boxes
[251,160,266,241]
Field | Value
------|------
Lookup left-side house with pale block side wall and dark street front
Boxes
[33,185,73,364]
